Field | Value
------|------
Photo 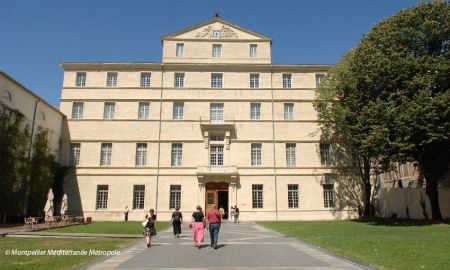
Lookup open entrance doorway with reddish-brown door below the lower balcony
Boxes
[205,182,229,219]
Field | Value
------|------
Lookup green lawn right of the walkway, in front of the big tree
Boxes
[260,220,450,270]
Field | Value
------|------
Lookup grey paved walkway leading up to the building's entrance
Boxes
[81,223,372,270]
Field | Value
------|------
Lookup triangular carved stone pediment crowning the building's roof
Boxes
[161,18,272,42]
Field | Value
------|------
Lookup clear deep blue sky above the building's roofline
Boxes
[0,0,419,105]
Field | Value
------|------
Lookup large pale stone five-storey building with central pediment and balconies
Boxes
[61,17,352,220]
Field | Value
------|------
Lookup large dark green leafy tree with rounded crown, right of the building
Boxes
[318,1,450,220]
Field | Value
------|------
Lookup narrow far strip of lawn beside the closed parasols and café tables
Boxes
[41,221,170,235]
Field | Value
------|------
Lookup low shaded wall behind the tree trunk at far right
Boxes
[378,188,450,219]
